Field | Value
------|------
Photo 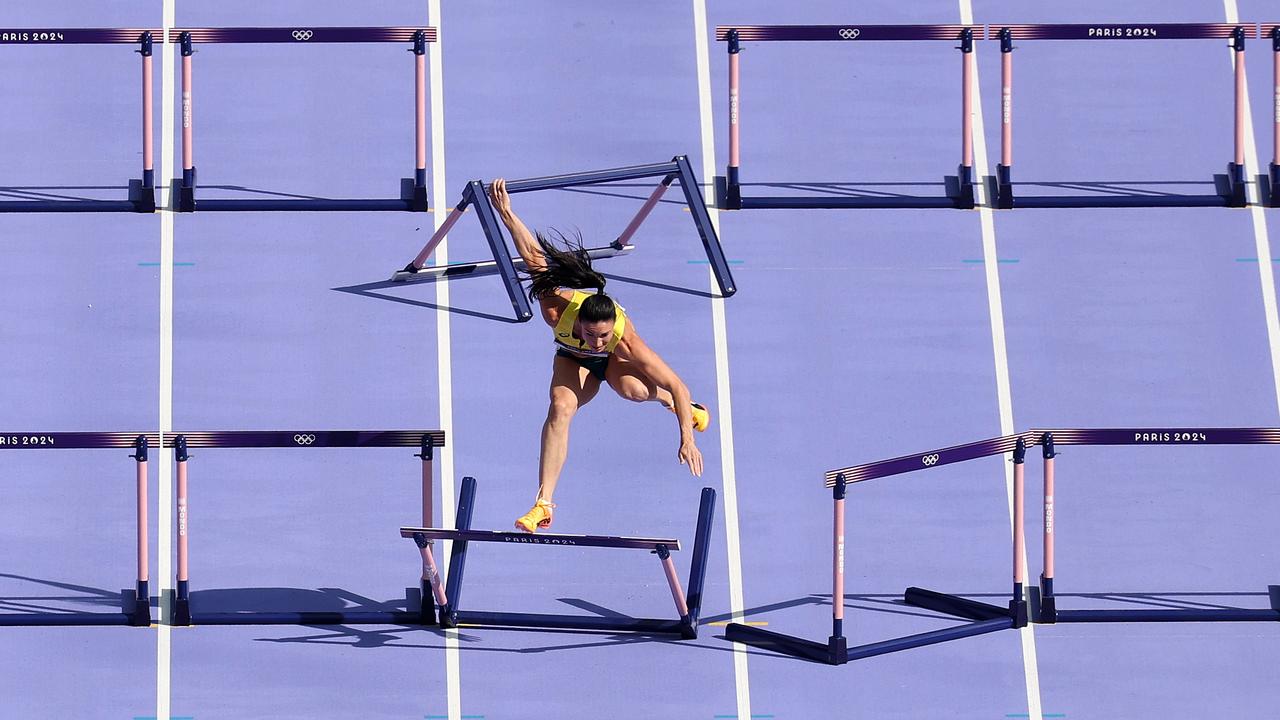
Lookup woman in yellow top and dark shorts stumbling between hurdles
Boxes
[489,178,710,533]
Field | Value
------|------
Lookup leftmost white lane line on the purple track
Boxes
[155,0,175,720]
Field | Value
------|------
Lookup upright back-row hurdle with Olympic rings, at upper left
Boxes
[169,27,435,213]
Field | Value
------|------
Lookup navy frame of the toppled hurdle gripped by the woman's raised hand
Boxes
[393,155,737,323]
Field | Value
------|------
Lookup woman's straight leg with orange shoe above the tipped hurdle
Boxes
[516,355,600,533]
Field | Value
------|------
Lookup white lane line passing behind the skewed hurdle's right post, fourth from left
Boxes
[960,0,1044,720]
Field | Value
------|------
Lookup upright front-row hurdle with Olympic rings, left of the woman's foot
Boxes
[164,430,444,625]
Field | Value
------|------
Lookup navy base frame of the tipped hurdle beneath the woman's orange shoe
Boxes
[424,478,716,639]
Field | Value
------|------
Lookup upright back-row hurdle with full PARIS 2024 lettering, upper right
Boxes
[987,23,1254,209]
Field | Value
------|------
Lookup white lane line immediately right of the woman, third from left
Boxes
[694,0,751,720]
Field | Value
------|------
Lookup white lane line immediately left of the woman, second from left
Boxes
[422,0,462,720]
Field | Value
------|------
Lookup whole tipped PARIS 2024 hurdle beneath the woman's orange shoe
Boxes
[401,478,716,639]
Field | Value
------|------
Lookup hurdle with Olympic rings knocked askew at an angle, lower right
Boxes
[724,434,1027,665]
